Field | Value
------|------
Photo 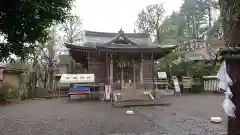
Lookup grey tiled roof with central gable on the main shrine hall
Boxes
[65,29,175,52]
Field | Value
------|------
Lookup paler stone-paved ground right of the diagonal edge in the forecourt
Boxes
[134,95,226,135]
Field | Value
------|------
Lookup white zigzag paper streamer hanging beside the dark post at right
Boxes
[217,61,236,118]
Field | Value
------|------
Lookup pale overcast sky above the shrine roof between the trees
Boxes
[73,0,182,32]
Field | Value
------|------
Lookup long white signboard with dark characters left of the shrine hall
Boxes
[60,74,95,83]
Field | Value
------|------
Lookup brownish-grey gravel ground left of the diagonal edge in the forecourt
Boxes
[0,99,167,135]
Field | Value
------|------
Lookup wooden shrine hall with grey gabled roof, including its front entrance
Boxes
[65,29,175,100]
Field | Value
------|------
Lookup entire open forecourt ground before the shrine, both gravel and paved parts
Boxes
[0,95,227,135]
